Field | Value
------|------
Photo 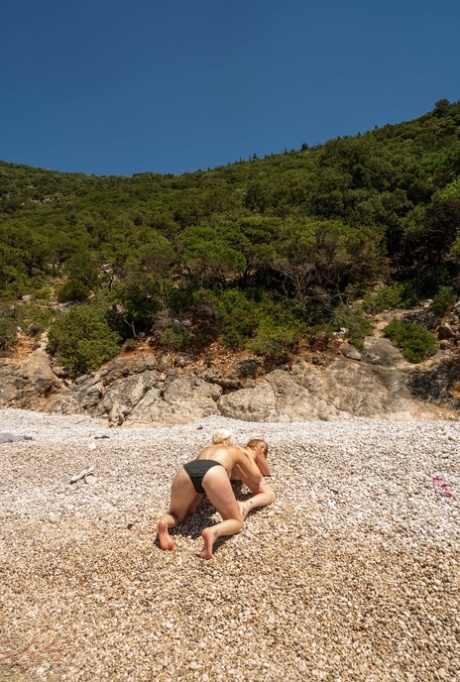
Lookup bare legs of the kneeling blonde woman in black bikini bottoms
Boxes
[158,466,243,559]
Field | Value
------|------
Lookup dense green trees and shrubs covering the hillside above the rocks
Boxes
[0,100,460,376]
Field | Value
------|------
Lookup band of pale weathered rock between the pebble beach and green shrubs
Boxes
[0,326,454,426]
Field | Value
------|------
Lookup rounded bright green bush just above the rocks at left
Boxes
[47,305,120,377]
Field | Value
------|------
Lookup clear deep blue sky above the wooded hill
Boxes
[0,0,460,176]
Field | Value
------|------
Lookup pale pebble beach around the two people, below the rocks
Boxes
[0,410,460,682]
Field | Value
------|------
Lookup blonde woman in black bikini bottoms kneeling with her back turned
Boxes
[158,429,262,559]
